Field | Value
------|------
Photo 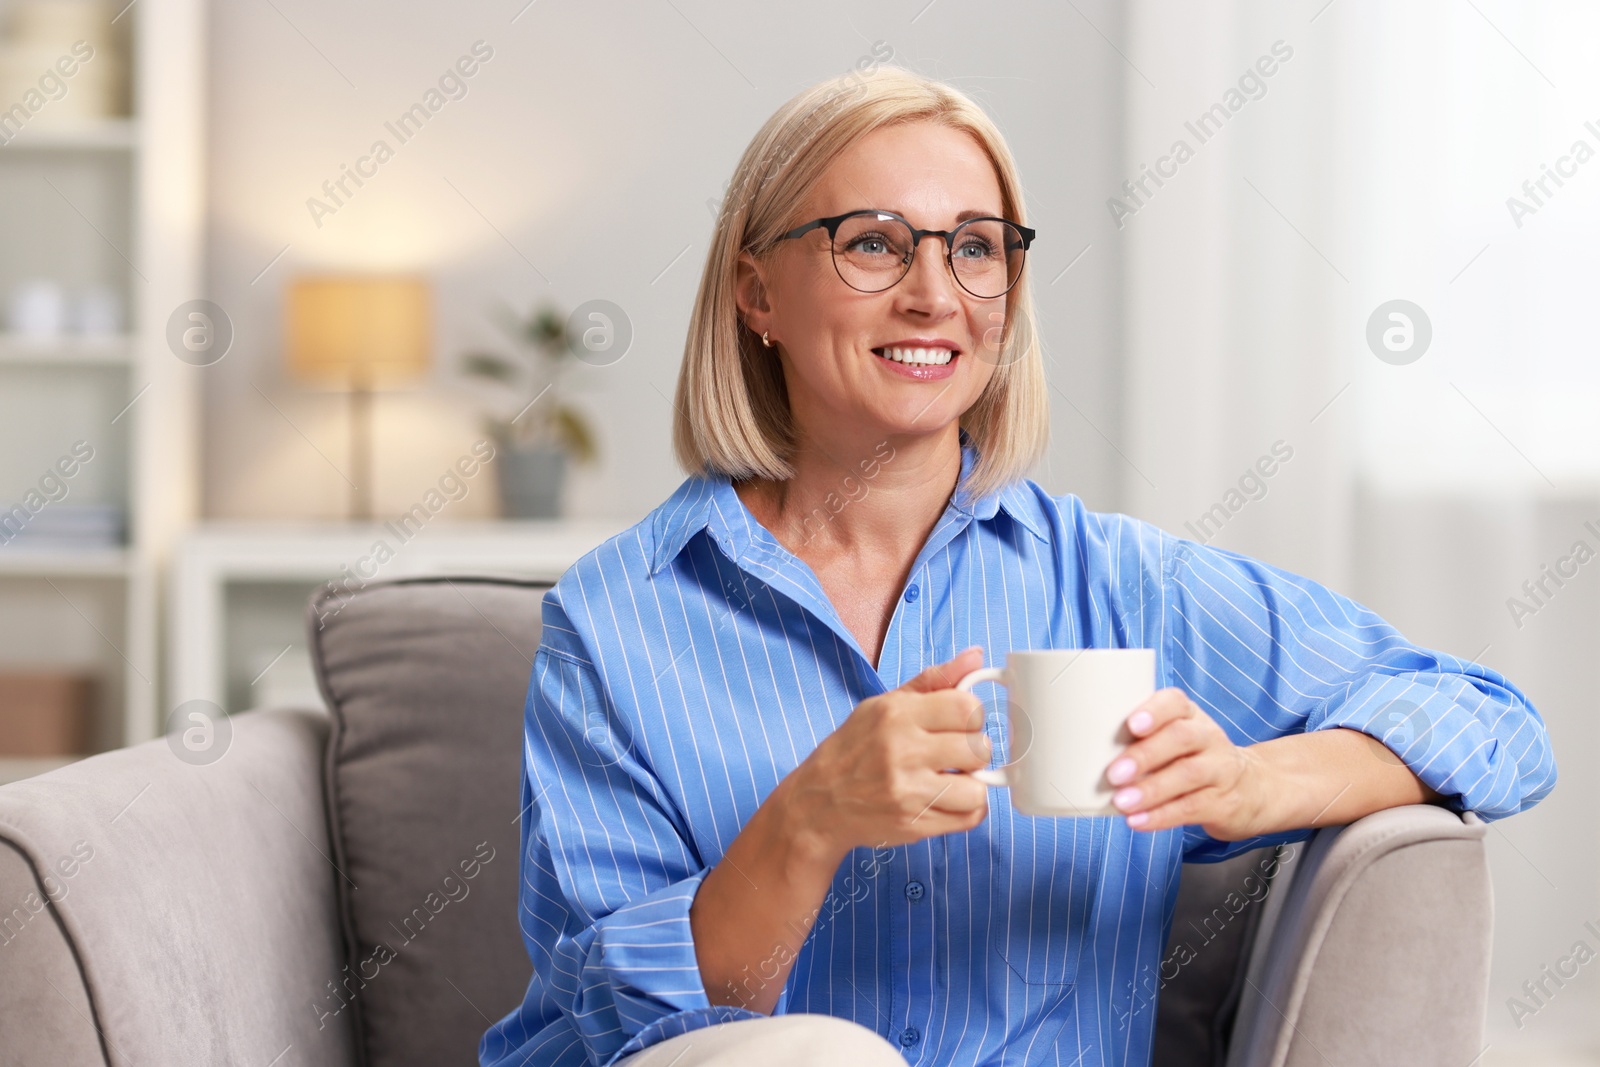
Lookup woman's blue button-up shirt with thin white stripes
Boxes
[478,432,1555,1067]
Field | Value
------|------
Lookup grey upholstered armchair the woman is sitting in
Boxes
[0,577,1491,1067]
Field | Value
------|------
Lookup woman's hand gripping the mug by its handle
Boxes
[782,646,990,861]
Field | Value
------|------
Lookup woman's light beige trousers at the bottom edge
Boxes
[616,1013,906,1067]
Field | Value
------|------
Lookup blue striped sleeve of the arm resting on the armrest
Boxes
[1141,528,1555,859]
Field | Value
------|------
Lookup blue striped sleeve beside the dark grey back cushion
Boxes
[480,611,755,1065]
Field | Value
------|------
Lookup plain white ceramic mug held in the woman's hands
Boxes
[955,648,1155,816]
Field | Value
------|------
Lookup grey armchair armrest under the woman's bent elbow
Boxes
[1227,805,1494,1067]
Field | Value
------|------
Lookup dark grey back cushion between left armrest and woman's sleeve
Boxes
[307,577,549,1067]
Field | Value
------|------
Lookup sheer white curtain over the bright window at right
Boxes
[1126,0,1600,1064]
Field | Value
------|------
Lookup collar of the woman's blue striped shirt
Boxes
[650,429,1050,574]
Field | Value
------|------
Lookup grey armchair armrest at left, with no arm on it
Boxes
[0,710,355,1067]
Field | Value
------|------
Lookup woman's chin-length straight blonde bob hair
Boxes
[672,67,1050,498]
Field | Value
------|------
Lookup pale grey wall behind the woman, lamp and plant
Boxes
[205,0,1122,518]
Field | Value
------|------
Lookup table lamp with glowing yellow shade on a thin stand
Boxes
[285,275,432,520]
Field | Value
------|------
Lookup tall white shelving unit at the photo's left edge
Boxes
[0,0,205,781]
